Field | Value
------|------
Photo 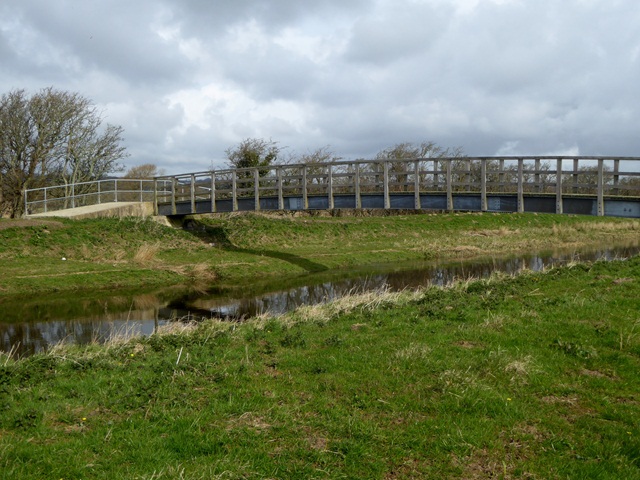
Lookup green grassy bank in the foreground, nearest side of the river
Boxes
[0,253,640,479]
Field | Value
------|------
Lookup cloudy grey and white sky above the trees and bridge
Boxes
[0,0,640,174]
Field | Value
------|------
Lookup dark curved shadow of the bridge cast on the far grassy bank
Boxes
[183,220,328,273]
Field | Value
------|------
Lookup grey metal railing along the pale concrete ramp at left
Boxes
[24,178,169,215]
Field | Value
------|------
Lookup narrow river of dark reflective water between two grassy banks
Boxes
[0,244,640,357]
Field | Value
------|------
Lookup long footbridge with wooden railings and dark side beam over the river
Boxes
[25,156,640,218]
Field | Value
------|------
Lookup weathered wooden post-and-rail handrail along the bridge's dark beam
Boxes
[155,156,640,215]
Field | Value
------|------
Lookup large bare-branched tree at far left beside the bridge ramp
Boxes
[0,88,127,217]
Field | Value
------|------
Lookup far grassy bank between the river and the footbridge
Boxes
[0,214,640,297]
